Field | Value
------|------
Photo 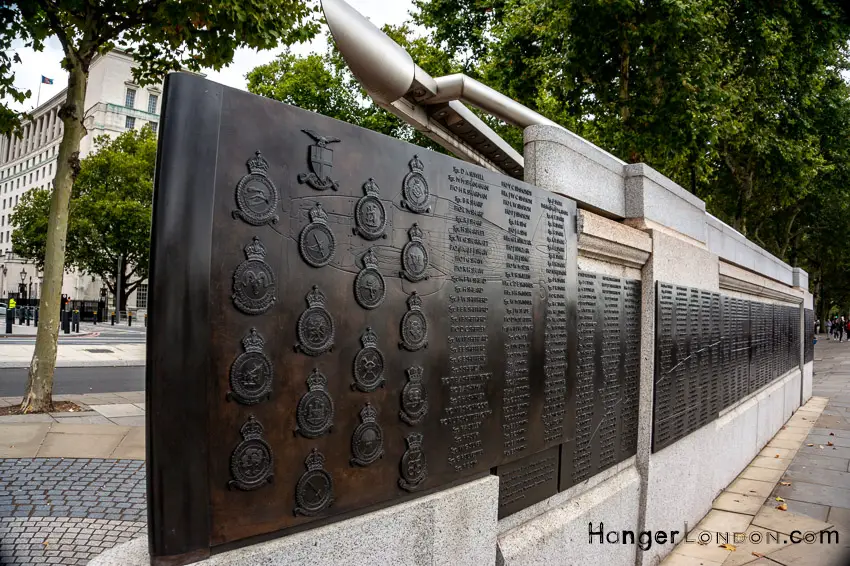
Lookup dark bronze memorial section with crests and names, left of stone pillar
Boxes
[147,74,641,564]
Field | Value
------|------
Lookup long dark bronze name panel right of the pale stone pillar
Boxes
[653,282,800,451]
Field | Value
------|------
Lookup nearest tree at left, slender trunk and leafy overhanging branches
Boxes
[0,0,318,412]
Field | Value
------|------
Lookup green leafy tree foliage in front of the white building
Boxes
[11,127,156,306]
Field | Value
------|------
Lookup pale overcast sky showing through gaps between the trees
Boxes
[4,0,413,110]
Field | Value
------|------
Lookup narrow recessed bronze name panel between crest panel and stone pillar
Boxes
[560,271,641,490]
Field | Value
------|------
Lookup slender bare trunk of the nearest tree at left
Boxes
[21,62,88,413]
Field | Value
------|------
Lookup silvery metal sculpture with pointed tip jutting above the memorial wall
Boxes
[322,0,560,178]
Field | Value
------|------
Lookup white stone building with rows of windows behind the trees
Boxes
[0,50,162,309]
